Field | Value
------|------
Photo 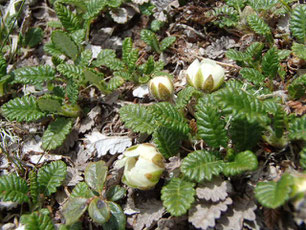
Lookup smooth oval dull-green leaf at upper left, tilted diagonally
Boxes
[51,30,79,60]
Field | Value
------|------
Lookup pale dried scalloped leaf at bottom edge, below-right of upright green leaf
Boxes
[188,197,233,229]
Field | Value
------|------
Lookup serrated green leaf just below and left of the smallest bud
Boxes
[119,105,156,134]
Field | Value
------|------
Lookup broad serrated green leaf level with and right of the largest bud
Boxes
[181,150,224,182]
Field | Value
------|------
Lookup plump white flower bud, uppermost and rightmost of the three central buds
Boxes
[186,59,225,93]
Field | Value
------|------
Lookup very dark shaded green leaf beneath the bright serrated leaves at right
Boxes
[229,117,263,151]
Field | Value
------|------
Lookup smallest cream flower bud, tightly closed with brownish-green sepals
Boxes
[149,76,174,101]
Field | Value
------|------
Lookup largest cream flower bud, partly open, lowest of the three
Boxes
[115,144,165,190]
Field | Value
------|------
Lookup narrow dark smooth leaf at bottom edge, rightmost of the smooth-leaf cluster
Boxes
[102,202,126,230]
